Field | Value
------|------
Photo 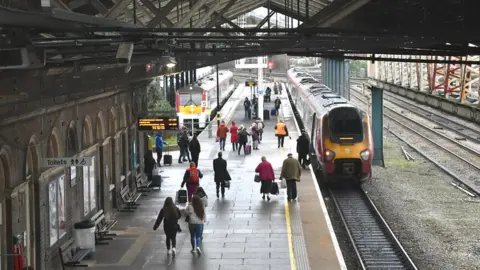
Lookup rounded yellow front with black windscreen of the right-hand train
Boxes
[322,106,373,184]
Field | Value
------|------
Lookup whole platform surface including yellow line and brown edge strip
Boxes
[78,79,346,270]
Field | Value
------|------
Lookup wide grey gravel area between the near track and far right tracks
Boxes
[364,137,480,269]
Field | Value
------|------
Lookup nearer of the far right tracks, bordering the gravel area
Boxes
[350,90,480,194]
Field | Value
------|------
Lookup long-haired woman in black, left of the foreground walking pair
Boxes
[153,197,182,256]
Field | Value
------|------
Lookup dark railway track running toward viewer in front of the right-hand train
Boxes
[329,188,417,269]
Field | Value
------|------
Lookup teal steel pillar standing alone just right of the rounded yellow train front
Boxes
[370,86,385,166]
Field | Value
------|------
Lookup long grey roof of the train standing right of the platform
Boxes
[287,69,356,113]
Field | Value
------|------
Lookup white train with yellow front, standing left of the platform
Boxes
[175,70,235,129]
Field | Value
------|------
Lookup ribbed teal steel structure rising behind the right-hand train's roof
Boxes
[322,58,350,100]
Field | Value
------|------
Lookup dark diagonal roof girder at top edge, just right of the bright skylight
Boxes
[299,0,370,27]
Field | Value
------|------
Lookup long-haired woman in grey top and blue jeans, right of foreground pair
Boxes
[187,196,207,255]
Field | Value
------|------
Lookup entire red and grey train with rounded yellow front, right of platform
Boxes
[287,68,374,185]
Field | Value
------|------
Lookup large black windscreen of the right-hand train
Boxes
[328,107,363,144]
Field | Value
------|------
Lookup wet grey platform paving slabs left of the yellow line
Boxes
[81,89,300,270]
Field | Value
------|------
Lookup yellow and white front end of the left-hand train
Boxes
[175,84,207,129]
